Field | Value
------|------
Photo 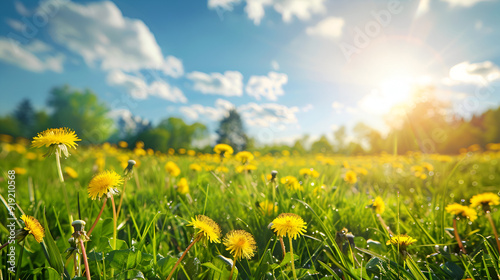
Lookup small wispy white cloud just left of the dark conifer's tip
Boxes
[179,98,234,121]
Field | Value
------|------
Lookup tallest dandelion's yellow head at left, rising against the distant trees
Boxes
[31,127,81,157]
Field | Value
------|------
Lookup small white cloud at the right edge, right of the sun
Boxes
[448,61,500,85]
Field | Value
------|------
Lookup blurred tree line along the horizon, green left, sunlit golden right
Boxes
[0,86,500,155]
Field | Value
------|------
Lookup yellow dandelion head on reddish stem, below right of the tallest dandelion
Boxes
[88,171,123,200]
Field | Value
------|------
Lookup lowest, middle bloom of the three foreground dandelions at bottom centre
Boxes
[223,230,257,260]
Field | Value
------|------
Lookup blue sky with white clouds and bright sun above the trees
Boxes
[0,0,500,143]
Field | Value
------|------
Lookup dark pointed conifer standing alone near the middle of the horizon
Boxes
[217,109,248,151]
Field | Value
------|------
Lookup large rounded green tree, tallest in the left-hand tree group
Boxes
[48,86,114,143]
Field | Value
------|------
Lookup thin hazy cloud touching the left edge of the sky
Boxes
[0,37,65,72]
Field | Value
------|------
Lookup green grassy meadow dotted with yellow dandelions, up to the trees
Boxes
[0,132,500,279]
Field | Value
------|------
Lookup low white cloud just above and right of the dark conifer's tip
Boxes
[238,102,300,127]
